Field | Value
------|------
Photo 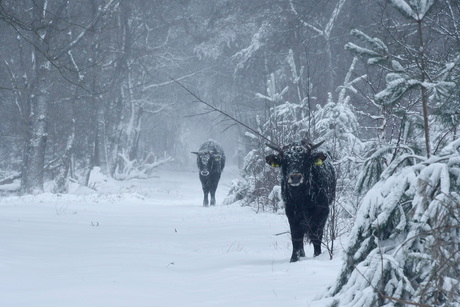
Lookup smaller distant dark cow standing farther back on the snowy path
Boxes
[192,140,225,207]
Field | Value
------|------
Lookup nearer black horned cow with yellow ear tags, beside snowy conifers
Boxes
[266,140,336,262]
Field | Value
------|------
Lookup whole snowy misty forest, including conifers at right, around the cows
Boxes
[0,0,460,306]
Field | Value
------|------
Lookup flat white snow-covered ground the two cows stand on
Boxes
[0,170,341,307]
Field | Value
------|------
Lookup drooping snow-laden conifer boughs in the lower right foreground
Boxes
[313,139,460,307]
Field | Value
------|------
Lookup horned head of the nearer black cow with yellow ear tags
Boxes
[265,140,326,187]
